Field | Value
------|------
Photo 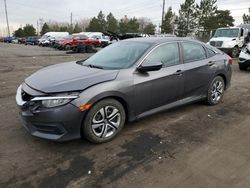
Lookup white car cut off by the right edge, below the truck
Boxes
[238,43,250,70]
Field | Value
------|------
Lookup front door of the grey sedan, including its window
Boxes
[134,42,184,115]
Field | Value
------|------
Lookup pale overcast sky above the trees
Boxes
[0,0,250,35]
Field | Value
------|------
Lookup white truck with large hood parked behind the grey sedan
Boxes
[209,27,248,58]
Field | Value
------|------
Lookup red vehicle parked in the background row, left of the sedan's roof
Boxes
[59,35,100,50]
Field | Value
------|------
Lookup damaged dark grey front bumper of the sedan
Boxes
[16,85,85,141]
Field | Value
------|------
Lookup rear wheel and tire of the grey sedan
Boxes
[207,76,225,105]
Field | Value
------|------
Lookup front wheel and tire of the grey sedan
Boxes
[82,99,126,143]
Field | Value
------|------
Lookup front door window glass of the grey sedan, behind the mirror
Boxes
[145,43,180,67]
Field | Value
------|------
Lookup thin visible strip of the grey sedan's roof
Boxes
[125,37,201,44]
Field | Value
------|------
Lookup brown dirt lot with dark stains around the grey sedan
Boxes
[0,43,250,188]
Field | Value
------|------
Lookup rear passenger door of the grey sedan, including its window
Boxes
[181,42,217,98]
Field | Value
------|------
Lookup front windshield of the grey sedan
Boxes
[83,41,150,69]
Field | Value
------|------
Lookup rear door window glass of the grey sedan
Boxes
[182,43,206,62]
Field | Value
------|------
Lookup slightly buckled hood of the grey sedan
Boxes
[25,62,119,93]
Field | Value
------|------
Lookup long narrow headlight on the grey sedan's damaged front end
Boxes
[31,94,78,108]
